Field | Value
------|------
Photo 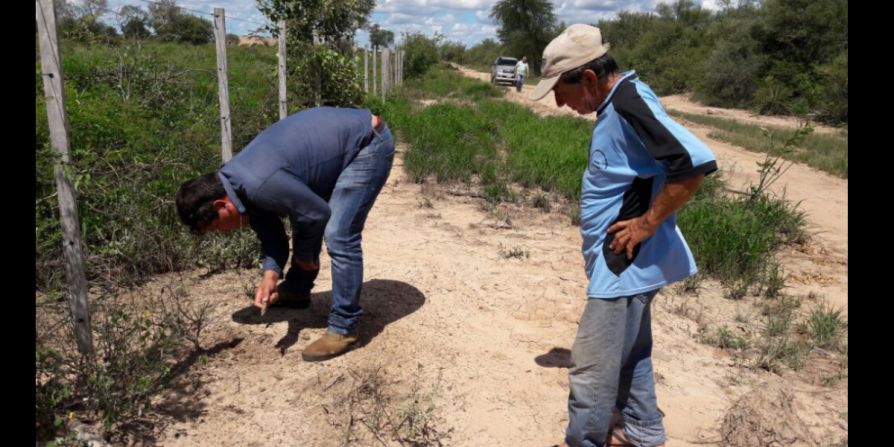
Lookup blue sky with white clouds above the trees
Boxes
[100,0,717,48]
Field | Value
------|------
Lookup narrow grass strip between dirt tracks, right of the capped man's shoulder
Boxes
[669,111,848,178]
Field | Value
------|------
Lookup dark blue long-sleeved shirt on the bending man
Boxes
[218,107,374,275]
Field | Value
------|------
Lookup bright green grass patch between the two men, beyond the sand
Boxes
[383,68,592,200]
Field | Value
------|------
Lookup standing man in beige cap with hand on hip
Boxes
[529,24,717,447]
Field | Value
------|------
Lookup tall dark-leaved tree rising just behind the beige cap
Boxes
[490,0,558,76]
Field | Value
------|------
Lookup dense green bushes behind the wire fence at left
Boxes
[35,44,278,290]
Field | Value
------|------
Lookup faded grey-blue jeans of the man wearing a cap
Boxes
[565,290,667,447]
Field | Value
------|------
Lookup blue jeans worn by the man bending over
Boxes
[283,126,394,335]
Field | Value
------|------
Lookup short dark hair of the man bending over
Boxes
[176,172,227,234]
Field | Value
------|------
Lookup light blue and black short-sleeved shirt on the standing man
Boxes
[581,71,717,298]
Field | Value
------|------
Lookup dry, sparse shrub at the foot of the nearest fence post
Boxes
[35,281,217,439]
